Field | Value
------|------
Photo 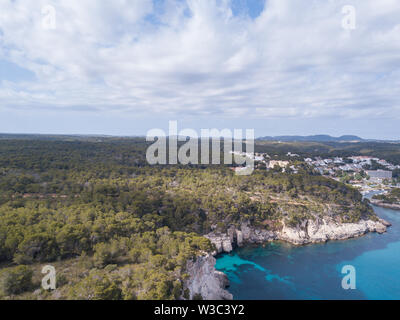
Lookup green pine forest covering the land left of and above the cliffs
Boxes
[0,138,373,299]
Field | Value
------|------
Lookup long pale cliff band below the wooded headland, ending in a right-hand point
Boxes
[205,217,390,254]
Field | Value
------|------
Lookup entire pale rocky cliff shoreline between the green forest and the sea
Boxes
[185,217,390,300]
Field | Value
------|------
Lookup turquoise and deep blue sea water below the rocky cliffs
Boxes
[216,202,400,299]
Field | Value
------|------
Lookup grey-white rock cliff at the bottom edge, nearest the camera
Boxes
[184,252,233,300]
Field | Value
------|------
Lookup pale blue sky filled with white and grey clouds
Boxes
[0,0,400,139]
